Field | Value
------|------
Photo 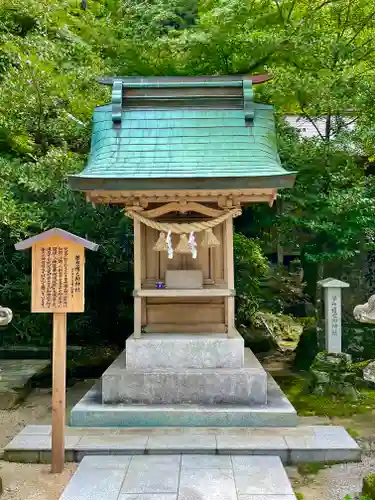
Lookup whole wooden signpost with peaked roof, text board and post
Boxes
[15,228,98,473]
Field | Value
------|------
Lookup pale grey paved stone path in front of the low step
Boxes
[60,454,296,500]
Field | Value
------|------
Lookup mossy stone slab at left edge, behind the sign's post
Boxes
[0,359,50,410]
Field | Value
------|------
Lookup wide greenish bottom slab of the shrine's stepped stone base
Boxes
[70,375,297,427]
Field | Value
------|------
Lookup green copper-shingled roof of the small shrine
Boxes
[69,79,294,190]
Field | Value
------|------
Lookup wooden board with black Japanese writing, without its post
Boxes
[31,236,85,313]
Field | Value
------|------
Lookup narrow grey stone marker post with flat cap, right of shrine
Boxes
[318,278,349,354]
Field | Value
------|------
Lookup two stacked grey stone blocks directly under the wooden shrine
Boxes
[102,348,267,405]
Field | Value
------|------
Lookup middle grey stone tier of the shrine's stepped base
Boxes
[101,348,267,405]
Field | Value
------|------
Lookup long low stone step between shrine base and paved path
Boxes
[4,425,361,464]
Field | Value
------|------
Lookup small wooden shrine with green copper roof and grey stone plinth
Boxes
[69,75,295,410]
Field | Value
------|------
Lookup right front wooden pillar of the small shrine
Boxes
[223,217,235,337]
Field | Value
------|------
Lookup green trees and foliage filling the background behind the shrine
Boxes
[0,0,375,348]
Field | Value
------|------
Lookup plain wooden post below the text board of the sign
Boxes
[52,313,66,473]
